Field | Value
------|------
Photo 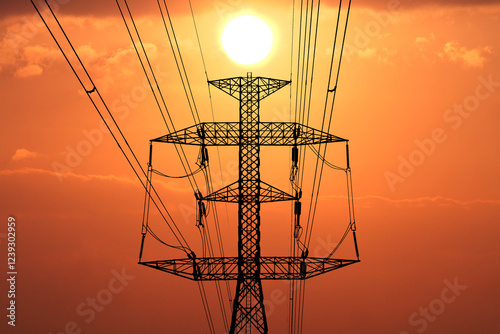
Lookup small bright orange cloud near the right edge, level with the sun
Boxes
[438,41,491,68]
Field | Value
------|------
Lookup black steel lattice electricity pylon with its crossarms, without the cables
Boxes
[139,73,358,334]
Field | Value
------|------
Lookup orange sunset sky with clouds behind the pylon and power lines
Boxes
[0,0,500,334]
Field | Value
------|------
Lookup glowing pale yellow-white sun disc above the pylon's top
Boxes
[222,15,273,65]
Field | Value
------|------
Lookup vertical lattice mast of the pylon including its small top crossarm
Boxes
[210,72,289,334]
